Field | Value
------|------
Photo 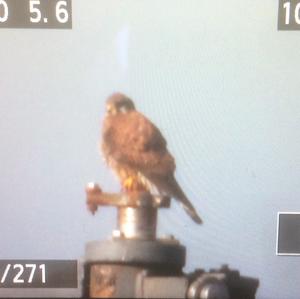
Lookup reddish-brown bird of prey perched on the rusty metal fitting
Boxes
[102,93,202,224]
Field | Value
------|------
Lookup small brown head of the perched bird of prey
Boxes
[106,93,135,115]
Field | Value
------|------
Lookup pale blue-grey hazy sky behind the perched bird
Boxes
[0,0,300,299]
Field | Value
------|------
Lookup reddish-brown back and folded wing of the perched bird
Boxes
[102,111,175,176]
